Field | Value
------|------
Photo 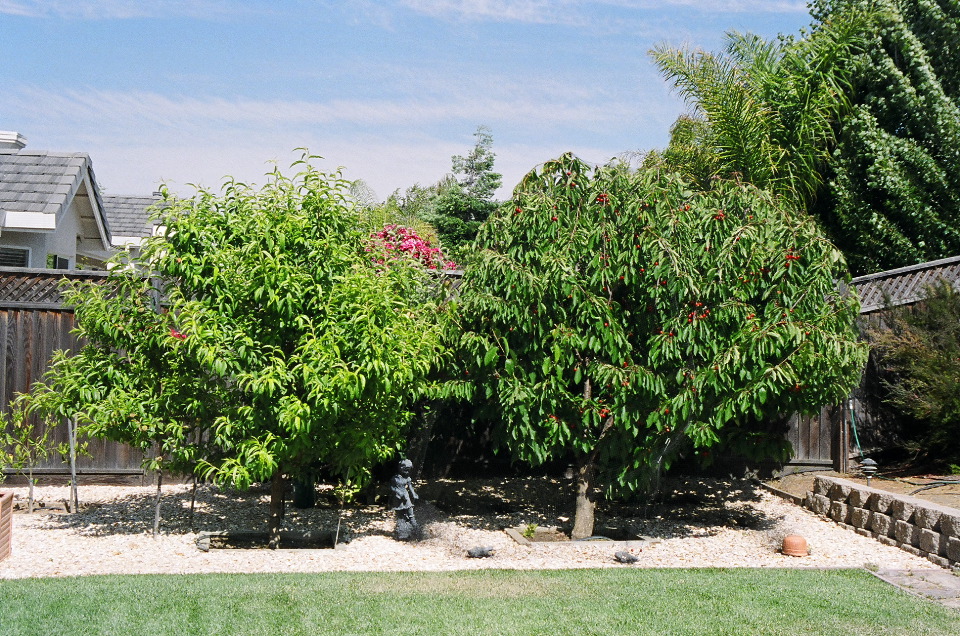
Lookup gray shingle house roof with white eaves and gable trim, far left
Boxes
[0,148,109,246]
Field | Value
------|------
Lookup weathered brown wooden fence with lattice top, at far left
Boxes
[0,267,143,474]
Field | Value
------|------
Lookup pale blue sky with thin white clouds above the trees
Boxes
[0,0,810,200]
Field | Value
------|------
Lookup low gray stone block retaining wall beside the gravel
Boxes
[804,476,960,567]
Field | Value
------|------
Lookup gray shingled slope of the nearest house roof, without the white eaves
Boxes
[0,149,92,214]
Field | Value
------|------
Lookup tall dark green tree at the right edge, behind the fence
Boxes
[812,0,960,274]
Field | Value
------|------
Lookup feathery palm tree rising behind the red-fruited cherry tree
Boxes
[651,11,867,207]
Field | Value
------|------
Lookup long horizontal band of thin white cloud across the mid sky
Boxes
[0,84,637,130]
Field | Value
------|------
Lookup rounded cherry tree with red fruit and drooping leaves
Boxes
[458,155,867,537]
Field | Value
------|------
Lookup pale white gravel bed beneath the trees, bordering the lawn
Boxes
[0,481,938,579]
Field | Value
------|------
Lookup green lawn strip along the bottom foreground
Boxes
[0,568,960,636]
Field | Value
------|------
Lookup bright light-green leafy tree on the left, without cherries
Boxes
[28,157,443,546]
